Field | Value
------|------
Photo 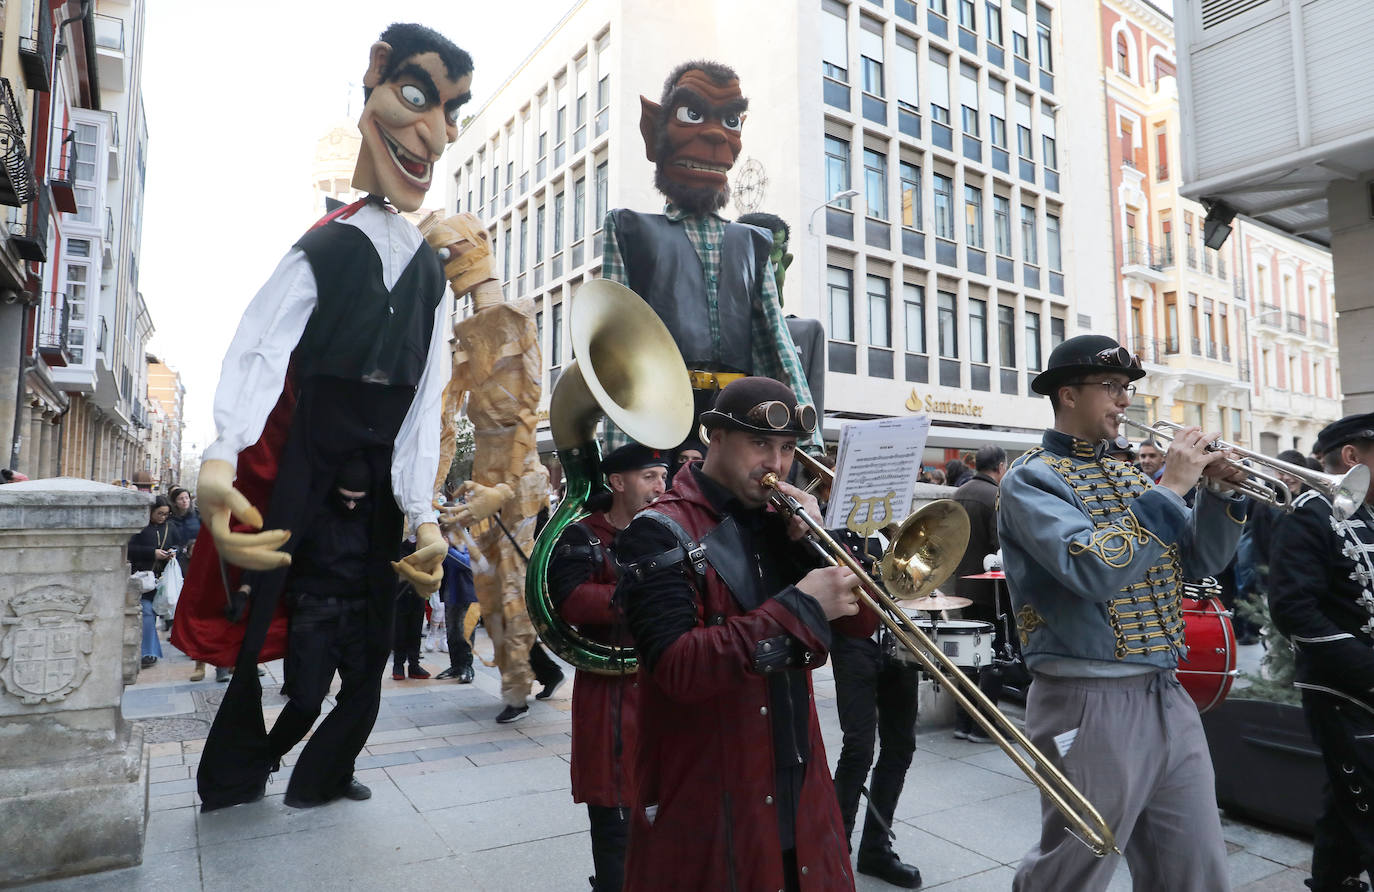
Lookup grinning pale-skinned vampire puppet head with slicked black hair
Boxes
[353,25,473,210]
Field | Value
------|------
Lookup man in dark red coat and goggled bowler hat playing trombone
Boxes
[617,378,877,892]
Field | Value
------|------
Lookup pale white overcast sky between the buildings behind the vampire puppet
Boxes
[139,0,573,455]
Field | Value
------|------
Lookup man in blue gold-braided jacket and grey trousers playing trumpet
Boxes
[998,335,1245,892]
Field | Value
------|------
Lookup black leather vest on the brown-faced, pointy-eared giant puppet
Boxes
[611,208,772,374]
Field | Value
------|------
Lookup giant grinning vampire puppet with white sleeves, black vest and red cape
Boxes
[173,25,473,810]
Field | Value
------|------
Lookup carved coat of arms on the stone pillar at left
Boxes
[0,586,95,704]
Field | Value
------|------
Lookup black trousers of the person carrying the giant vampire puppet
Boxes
[268,592,386,803]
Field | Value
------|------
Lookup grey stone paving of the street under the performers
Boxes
[24,638,1311,892]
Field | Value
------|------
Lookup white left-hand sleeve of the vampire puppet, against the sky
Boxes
[202,247,317,465]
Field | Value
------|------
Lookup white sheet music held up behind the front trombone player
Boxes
[826,414,930,537]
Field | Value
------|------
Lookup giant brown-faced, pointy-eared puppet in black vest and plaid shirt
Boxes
[602,60,822,448]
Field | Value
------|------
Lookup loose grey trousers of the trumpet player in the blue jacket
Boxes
[1011,672,1231,892]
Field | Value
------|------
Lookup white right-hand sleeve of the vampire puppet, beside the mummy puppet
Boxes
[392,287,453,529]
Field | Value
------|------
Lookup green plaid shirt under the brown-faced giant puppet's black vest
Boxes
[602,203,824,454]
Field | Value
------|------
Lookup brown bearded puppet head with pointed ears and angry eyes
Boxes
[639,62,749,214]
